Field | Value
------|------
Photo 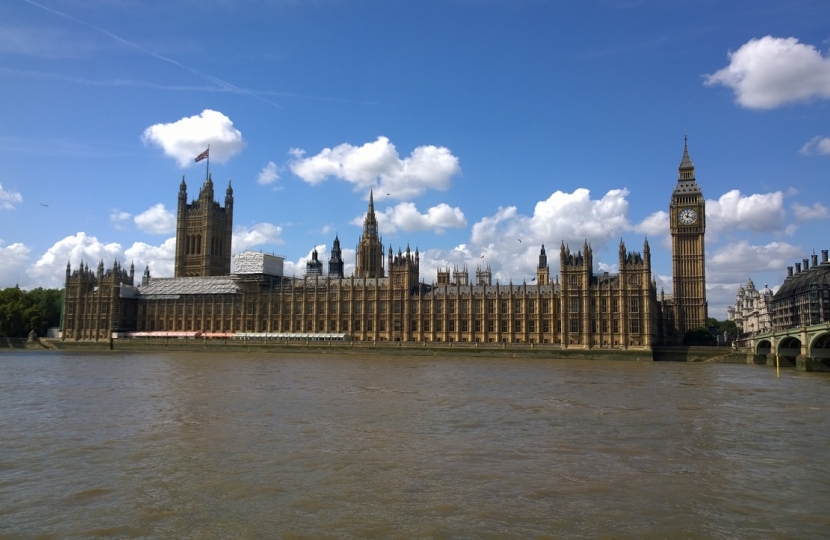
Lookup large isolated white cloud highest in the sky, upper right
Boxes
[705,36,830,109]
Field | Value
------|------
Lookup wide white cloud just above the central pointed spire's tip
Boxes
[290,137,461,200]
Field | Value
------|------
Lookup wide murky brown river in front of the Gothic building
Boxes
[0,352,830,539]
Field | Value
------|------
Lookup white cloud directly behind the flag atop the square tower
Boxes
[141,109,245,167]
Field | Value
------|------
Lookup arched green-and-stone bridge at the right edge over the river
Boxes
[749,322,830,371]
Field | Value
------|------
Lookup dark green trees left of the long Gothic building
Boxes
[0,287,61,337]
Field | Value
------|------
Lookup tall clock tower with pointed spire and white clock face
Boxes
[669,138,709,343]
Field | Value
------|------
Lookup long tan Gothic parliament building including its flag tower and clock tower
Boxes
[62,142,707,350]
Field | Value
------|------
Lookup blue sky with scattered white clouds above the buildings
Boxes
[0,0,830,318]
